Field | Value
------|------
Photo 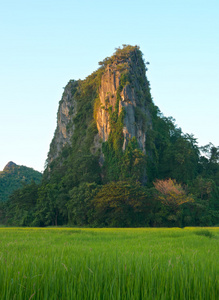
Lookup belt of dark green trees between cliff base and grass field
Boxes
[0,111,219,227]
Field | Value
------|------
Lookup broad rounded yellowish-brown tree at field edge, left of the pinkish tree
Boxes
[92,181,153,227]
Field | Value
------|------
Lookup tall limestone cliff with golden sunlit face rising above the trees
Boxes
[47,45,152,180]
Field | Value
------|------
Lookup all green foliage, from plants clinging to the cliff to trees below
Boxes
[0,46,219,227]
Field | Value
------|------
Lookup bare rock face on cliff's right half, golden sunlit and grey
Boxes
[96,52,151,152]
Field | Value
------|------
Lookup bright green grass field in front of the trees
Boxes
[0,228,219,300]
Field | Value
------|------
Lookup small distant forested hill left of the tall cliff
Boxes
[0,161,42,202]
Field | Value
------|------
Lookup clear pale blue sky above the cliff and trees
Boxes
[0,0,219,171]
